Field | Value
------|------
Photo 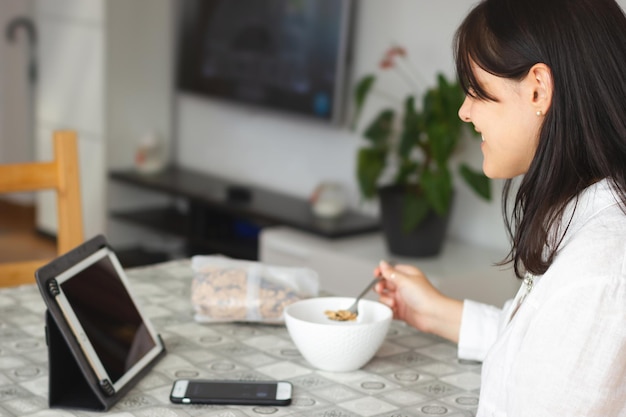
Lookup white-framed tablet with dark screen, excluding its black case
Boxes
[57,248,163,391]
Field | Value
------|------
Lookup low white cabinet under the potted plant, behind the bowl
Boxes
[259,227,520,306]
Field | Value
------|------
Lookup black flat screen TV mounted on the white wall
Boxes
[177,0,354,123]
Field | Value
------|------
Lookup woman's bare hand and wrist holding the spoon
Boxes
[374,261,463,342]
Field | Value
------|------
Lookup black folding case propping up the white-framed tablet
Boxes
[37,236,165,411]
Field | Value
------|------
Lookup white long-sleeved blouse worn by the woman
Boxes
[458,180,626,417]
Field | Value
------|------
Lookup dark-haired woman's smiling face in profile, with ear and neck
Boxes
[459,65,543,178]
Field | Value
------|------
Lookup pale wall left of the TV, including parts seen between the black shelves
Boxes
[104,0,181,252]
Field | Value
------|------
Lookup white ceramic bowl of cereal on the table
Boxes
[284,297,392,372]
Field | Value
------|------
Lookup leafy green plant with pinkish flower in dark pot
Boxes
[354,47,491,256]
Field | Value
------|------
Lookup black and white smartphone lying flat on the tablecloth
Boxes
[170,379,293,405]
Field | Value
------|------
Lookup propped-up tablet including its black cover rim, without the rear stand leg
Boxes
[37,237,164,396]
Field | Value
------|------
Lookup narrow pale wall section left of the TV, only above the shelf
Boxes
[105,0,174,168]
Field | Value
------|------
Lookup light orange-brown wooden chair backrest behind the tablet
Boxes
[0,131,84,287]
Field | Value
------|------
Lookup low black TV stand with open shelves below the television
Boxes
[110,166,379,260]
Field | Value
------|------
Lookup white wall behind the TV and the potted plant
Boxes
[178,0,506,247]
